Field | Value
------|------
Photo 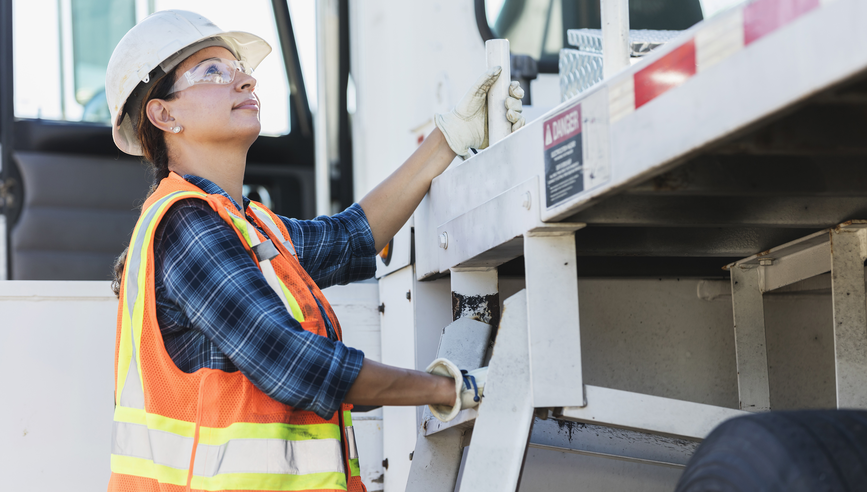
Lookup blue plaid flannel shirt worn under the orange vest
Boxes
[154,175,376,418]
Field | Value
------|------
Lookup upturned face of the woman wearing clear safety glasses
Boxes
[166,47,261,146]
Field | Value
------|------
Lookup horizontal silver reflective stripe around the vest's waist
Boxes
[111,422,346,477]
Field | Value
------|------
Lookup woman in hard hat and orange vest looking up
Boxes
[106,11,523,492]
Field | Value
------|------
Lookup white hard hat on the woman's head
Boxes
[105,10,271,155]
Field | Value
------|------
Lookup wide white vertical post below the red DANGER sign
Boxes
[524,229,586,408]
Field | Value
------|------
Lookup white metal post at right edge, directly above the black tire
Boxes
[831,229,867,408]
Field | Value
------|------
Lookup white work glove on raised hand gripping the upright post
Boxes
[434,67,524,158]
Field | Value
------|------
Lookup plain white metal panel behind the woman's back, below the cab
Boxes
[0,281,117,492]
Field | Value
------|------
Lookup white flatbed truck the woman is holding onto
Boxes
[0,0,867,491]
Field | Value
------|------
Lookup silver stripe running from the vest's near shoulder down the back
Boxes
[120,191,190,408]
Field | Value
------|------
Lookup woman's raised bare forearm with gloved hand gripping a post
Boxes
[359,67,524,251]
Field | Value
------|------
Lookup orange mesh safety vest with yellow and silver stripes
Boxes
[108,173,366,492]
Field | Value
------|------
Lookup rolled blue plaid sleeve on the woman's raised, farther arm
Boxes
[280,203,376,289]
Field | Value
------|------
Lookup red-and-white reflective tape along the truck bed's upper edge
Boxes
[608,0,833,123]
